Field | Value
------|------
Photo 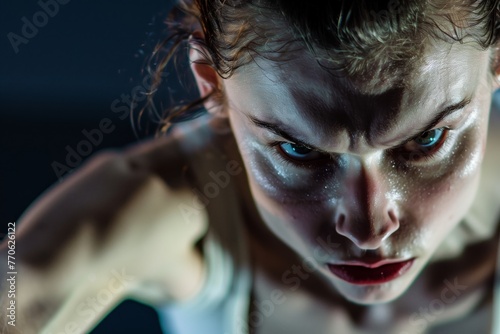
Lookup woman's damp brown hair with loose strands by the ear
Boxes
[142,0,500,135]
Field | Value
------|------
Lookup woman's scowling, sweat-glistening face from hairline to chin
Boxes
[223,38,493,304]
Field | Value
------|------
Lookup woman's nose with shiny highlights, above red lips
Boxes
[334,159,399,250]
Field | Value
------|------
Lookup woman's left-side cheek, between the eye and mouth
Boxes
[234,144,333,250]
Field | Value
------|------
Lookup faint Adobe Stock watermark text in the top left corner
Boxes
[7,0,70,54]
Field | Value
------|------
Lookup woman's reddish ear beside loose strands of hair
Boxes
[189,31,223,116]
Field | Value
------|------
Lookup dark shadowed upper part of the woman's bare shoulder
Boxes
[11,132,201,266]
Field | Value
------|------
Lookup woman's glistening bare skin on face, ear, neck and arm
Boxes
[0,13,500,333]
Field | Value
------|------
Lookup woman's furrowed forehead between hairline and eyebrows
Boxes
[225,42,489,152]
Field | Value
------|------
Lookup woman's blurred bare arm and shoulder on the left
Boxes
[0,134,208,333]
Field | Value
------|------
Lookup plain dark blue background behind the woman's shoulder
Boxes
[0,0,184,333]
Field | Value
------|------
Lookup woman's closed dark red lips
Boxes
[328,259,414,285]
